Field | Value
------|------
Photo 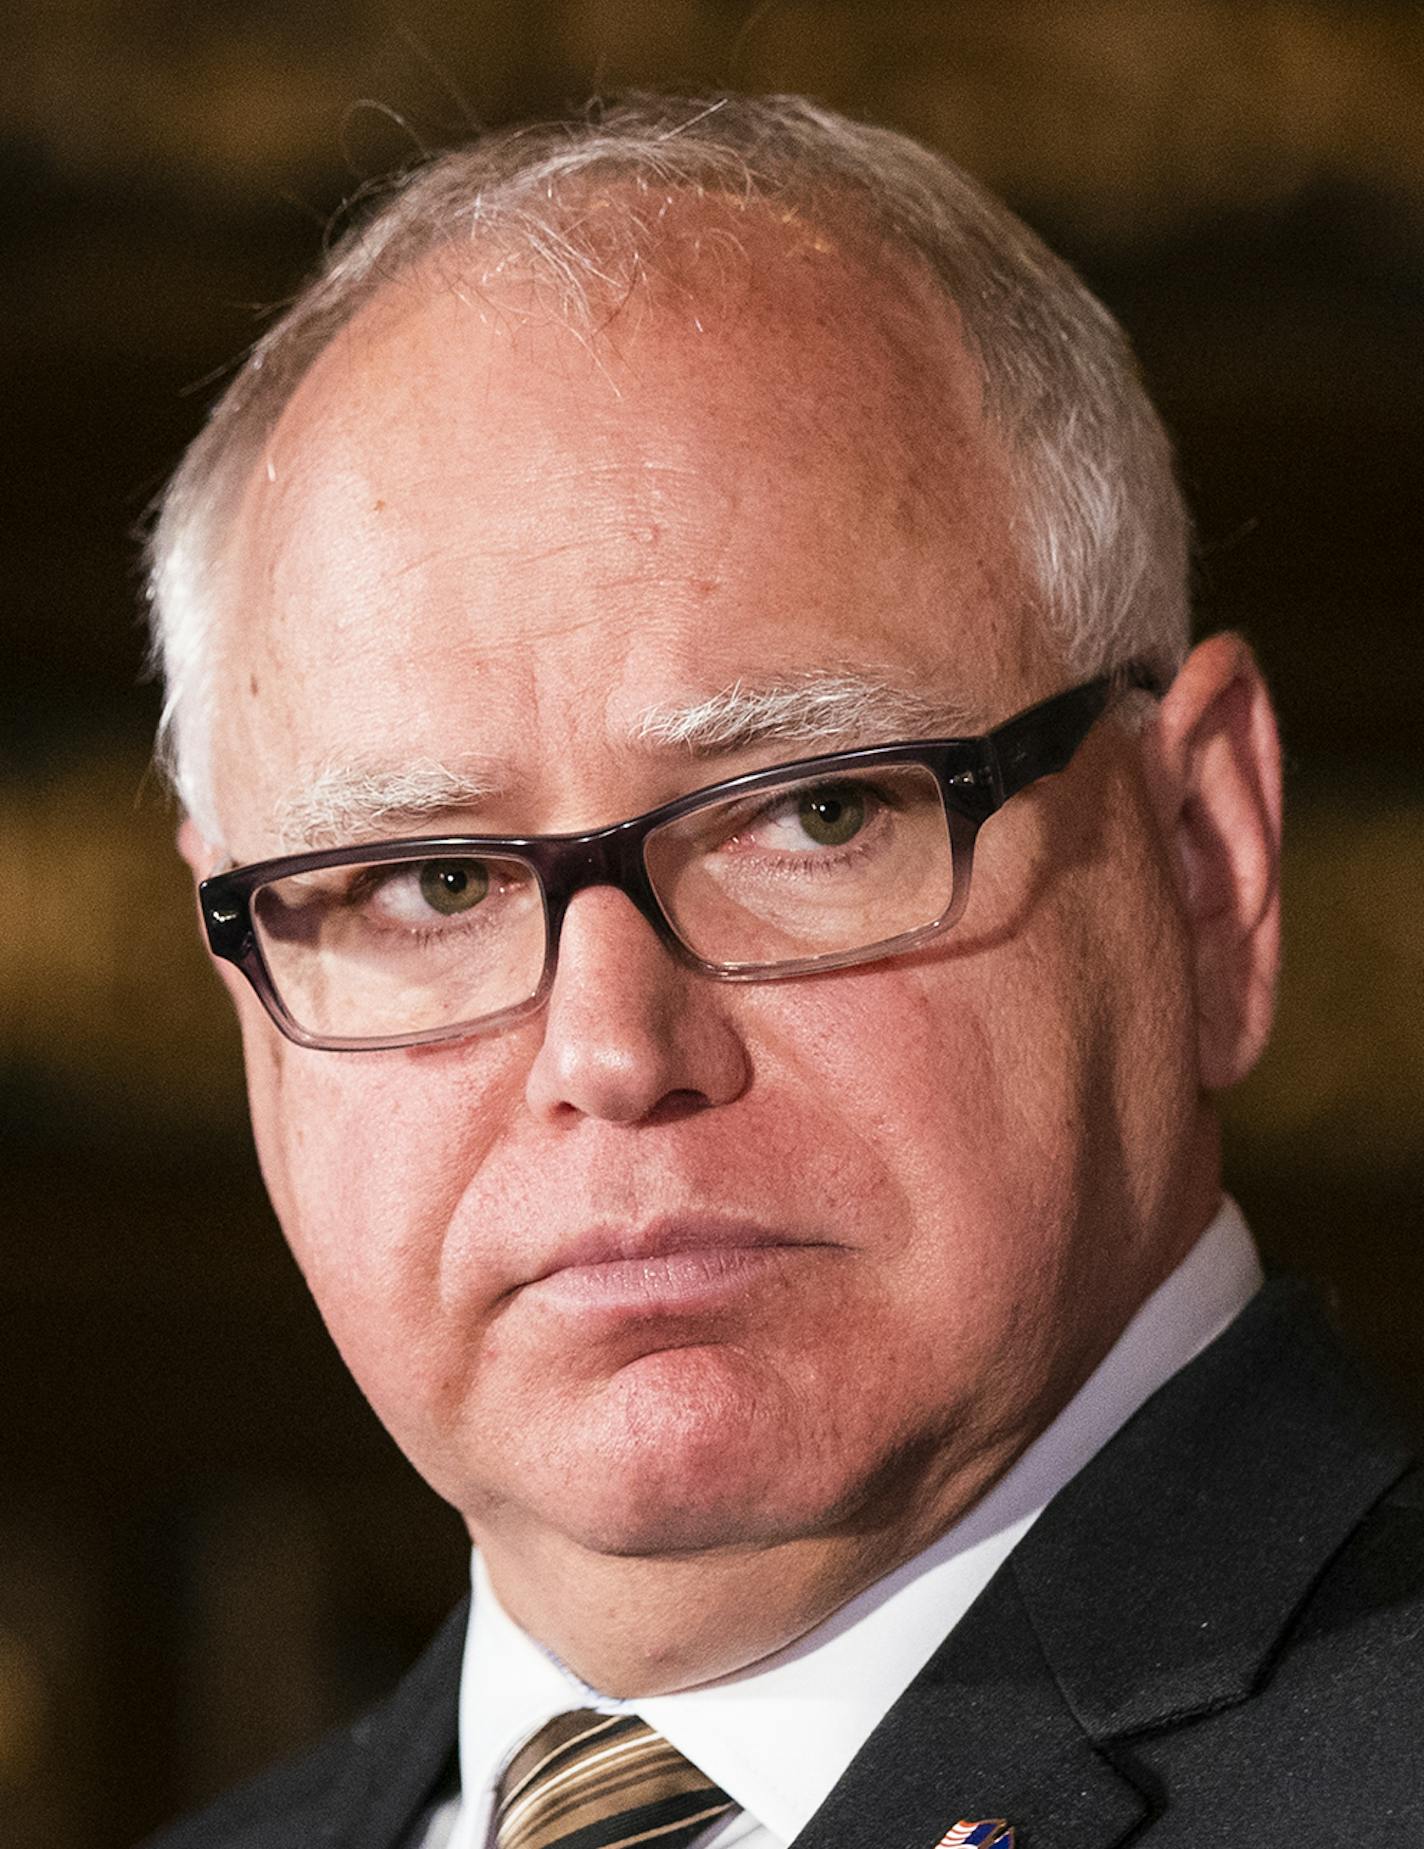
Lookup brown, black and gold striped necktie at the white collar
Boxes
[494,1708,732,1849]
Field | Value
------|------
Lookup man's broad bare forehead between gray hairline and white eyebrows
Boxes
[218,202,1041,846]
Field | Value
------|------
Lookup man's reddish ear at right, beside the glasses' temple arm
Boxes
[1145,634,1282,1091]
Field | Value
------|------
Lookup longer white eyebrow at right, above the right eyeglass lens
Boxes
[629,673,971,758]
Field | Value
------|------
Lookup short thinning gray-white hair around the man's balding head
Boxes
[148,86,1189,841]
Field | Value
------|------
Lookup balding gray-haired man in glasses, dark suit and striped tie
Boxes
[141,100,1424,1849]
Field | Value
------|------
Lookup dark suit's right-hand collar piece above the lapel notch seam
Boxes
[1008,1280,1409,1738]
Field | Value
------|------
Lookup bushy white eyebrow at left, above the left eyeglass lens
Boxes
[274,758,509,851]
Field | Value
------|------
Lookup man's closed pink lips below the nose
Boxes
[522,1217,830,1316]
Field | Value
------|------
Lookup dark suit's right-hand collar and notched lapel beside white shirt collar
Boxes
[795,1283,1409,1849]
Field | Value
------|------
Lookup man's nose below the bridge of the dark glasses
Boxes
[525,886,751,1124]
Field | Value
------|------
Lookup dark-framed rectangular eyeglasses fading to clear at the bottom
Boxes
[198,662,1160,1050]
